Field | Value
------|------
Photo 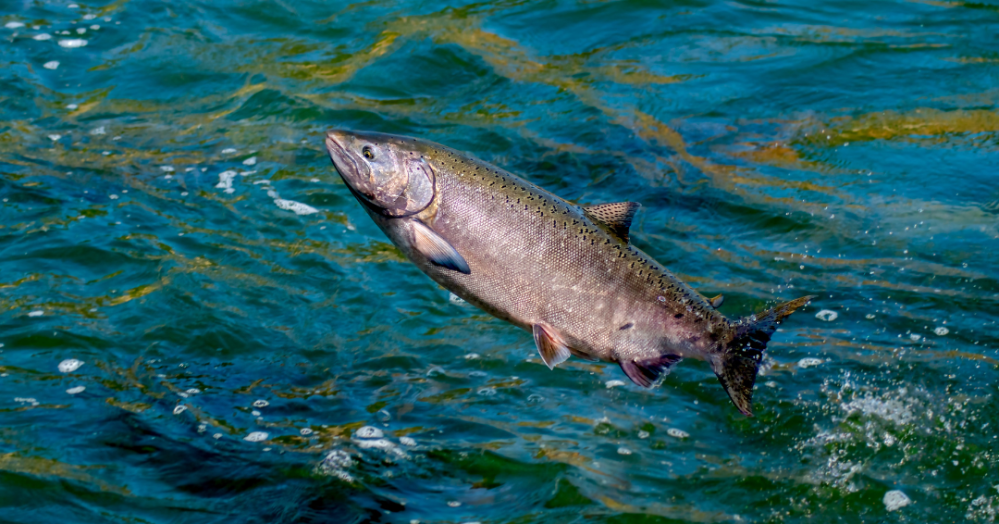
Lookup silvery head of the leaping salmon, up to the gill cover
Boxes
[326,130,434,217]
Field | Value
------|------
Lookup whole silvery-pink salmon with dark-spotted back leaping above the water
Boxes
[326,131,811,415]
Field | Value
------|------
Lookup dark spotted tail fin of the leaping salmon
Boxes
[711,296,815,417]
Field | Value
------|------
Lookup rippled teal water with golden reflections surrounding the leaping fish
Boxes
[0,0,999,524]
